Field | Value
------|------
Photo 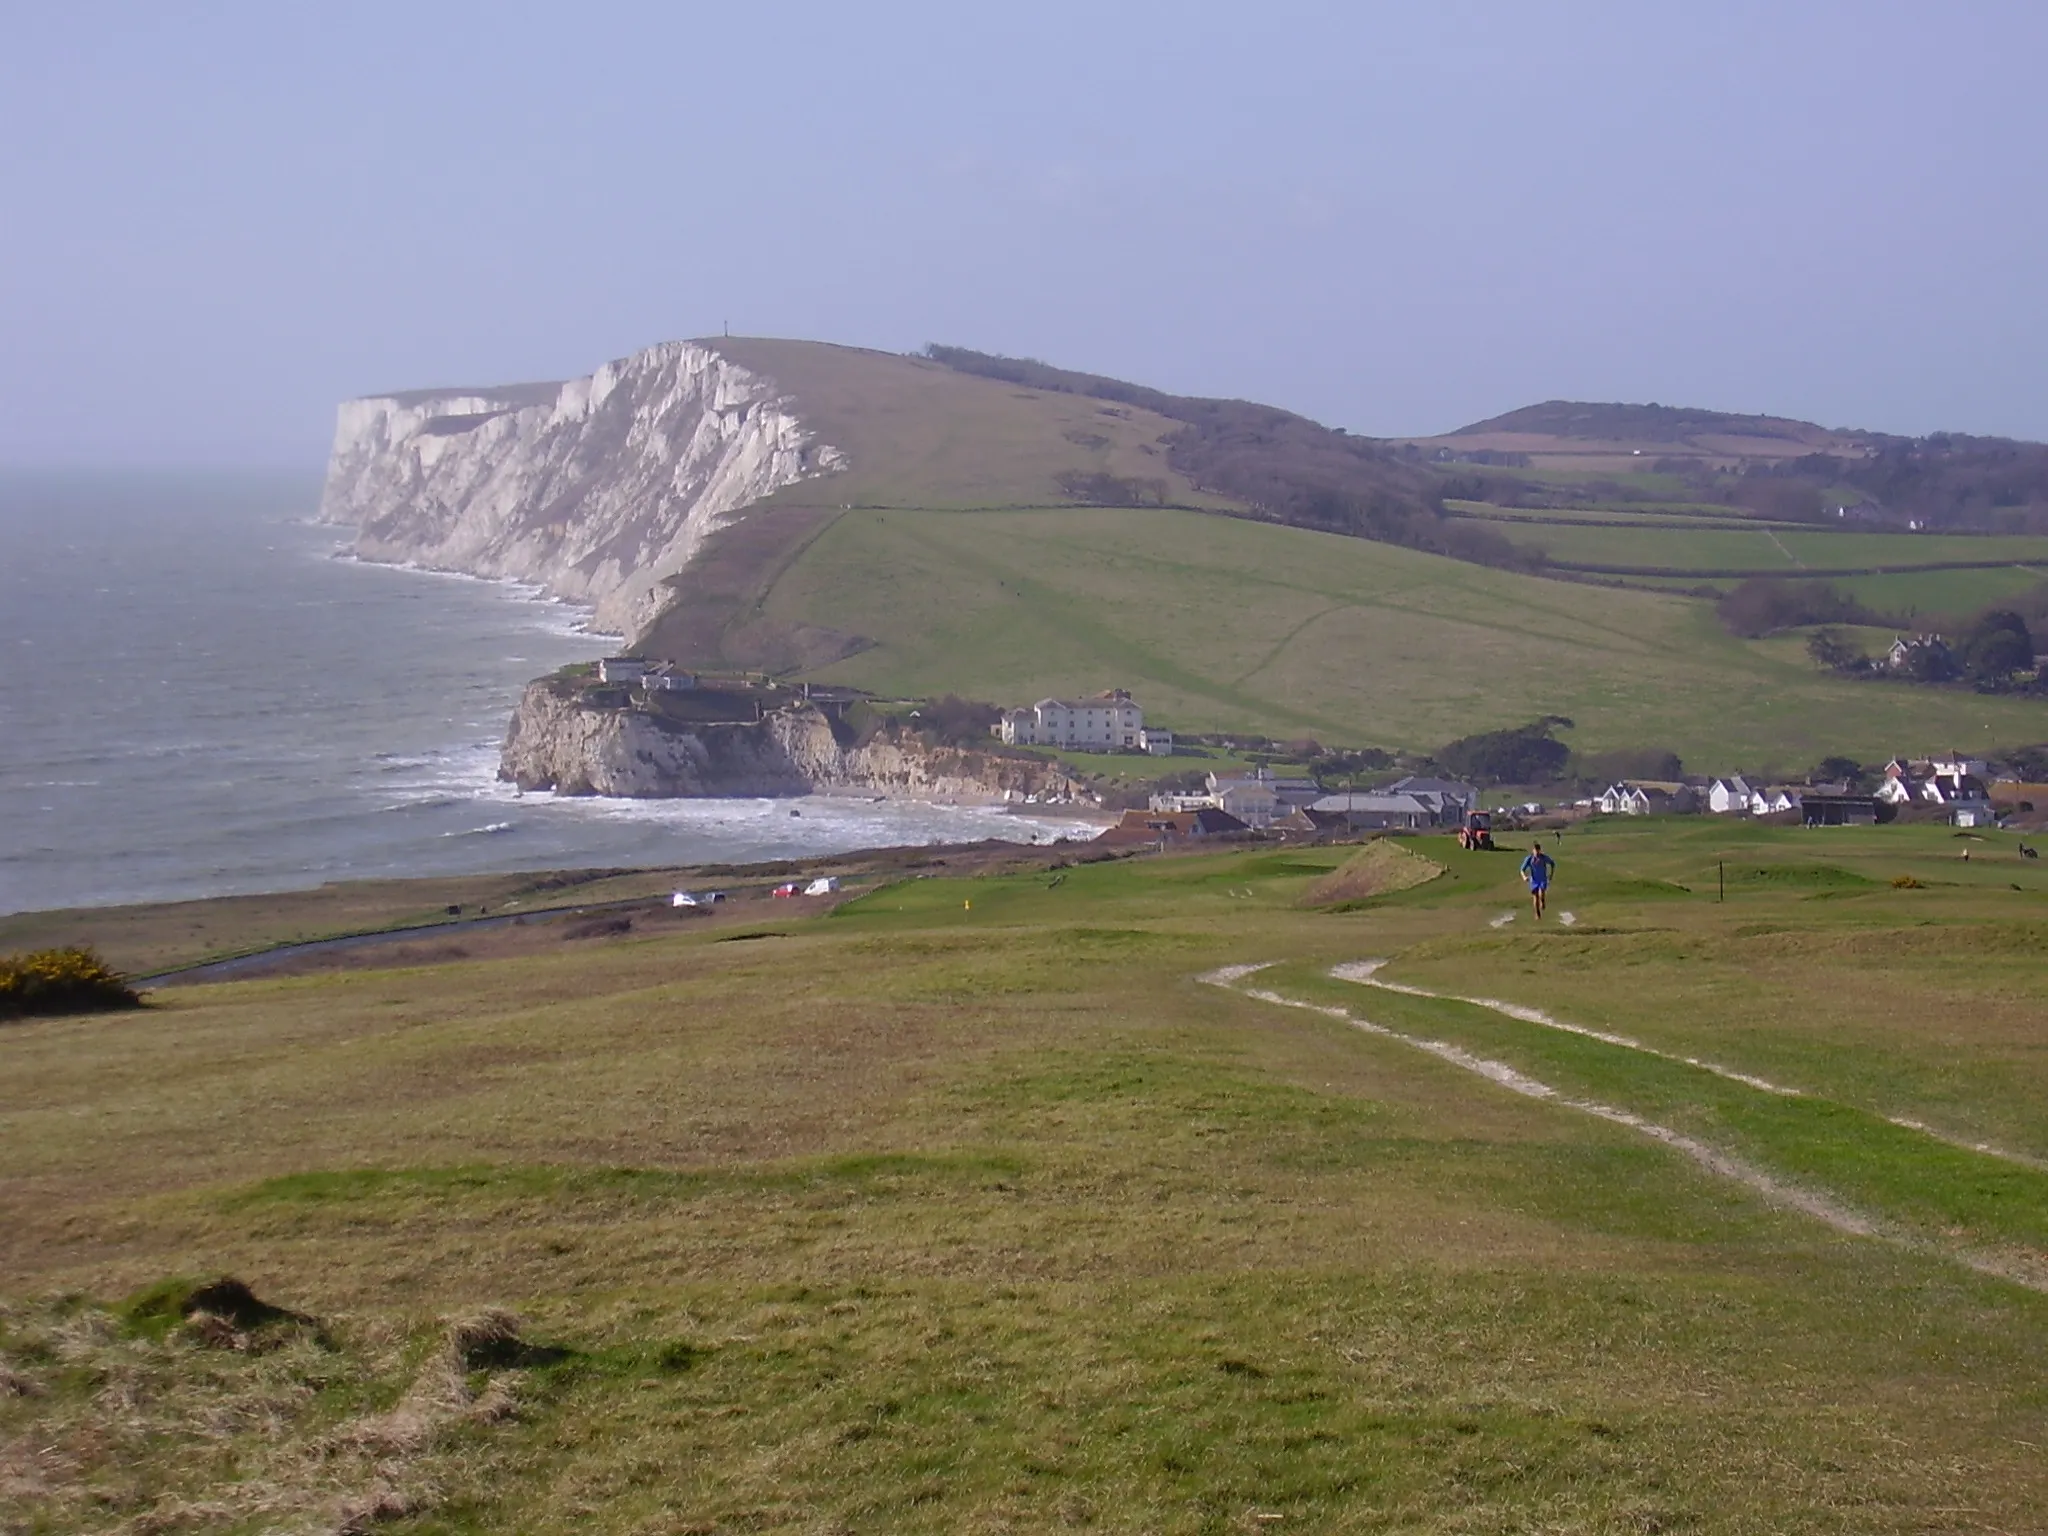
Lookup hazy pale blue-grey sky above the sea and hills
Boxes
[0,0,2048,465]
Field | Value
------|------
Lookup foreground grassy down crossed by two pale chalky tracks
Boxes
[0,817,2048,1532]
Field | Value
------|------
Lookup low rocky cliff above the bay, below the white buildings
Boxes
[498,680,1071,801]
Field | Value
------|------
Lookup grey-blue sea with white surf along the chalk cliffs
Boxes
[0,473,1073,911]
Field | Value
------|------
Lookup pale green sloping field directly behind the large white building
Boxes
[762,508,2044,768]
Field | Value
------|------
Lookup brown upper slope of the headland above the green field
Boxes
[639,338,1499,670]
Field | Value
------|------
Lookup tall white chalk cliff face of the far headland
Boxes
[319,342,846,633]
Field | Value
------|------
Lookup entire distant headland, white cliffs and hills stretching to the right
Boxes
[324,338,2048,768]
